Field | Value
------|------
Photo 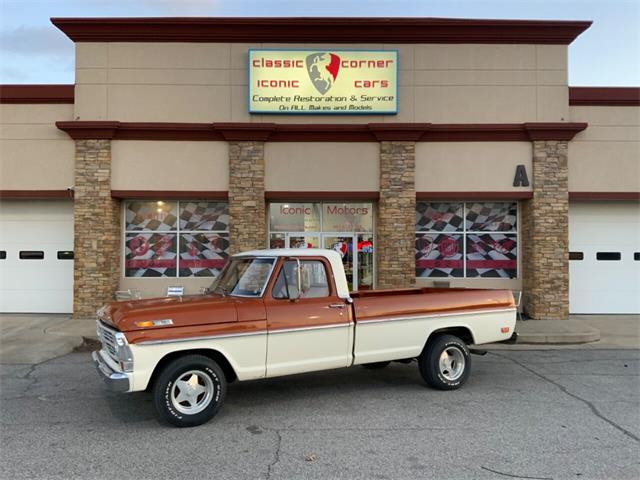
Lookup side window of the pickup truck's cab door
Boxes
[272,260,329,299]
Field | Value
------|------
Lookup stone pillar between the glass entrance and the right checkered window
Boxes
[376,142,416,288]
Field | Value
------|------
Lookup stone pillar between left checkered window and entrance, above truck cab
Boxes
[229,141,267,254]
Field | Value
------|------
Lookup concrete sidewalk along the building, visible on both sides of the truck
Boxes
[0,314,640,364]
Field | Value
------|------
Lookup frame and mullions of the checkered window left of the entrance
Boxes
[121,198,231,280]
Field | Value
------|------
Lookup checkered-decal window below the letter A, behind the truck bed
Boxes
[415,202,518,278]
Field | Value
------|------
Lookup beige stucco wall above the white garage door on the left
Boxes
[0,104,75,190]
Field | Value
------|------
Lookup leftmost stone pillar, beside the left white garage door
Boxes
[73,140,121,318]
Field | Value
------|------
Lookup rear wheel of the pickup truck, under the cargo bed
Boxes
[418,335,471,390]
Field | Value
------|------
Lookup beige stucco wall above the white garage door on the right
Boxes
[569,107,640,192]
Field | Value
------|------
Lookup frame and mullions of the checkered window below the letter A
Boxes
[414,199,521,281]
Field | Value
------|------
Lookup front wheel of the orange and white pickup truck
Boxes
[153,355,227,427]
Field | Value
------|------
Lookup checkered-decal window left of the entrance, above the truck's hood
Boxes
[124,200,229,277]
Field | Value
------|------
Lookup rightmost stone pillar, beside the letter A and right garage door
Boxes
[521,141,569,320]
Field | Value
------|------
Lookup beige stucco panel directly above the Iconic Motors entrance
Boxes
[265,142,380,192]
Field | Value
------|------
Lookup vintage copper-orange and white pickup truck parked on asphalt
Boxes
[92,249,516,427]
